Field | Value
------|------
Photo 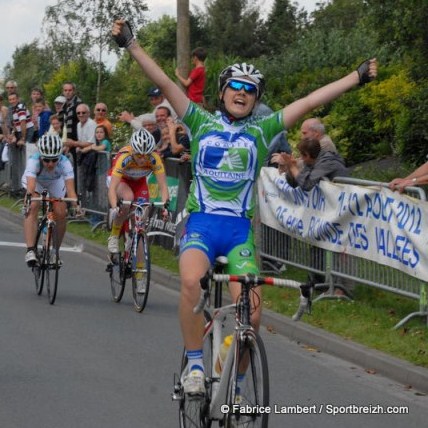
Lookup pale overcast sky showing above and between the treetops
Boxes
[0,0,318,73]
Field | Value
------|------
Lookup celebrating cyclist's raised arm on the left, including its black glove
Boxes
[112,19,190,117]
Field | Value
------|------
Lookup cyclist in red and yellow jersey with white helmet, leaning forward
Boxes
[107,128,169,253]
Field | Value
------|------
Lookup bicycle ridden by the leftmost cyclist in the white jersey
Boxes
[24,190,78,305]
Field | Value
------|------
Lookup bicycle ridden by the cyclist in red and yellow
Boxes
[106,200,165,312]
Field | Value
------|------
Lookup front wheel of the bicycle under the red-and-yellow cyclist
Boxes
[131,233,151,312]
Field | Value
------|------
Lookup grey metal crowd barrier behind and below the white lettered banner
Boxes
[259,178,428,329]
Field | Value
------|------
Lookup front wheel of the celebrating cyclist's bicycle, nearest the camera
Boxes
[224,330,269,428]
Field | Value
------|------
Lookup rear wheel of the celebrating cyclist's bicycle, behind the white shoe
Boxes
[179,311,213,428]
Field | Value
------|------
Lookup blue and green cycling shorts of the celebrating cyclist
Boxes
[180,213,259,275]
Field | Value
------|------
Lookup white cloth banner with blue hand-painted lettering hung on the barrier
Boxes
[258,168,428,281]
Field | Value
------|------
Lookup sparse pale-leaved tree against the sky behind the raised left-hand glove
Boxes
[44,0,147,100]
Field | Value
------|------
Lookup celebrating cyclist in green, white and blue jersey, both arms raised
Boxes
[112,20,377,394]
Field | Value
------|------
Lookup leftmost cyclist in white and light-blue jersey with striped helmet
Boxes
[22,135,78,267]
